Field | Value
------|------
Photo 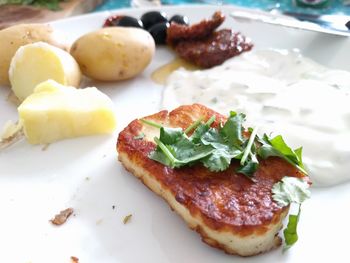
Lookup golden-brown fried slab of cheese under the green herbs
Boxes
[117,104,303,256]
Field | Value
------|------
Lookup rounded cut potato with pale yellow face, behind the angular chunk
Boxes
[9,42,81,100]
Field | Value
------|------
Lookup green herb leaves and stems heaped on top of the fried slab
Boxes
[142,111,307,179]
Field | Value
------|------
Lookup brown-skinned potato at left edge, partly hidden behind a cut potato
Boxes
[0,24,67,85]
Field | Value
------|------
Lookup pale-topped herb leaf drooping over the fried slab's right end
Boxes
[272,176,311,251]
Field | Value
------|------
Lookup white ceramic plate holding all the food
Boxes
[0,6,350,263]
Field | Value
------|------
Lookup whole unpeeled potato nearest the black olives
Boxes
[71,27,155,81]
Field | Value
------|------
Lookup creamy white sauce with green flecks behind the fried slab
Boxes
[162,50,350,186]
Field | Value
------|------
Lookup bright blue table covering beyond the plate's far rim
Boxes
[96,0,350,15]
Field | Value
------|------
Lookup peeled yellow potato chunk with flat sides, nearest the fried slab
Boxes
[18,80,116,144]
